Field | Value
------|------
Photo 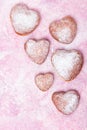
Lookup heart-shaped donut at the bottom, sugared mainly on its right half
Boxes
[52,90,80,115]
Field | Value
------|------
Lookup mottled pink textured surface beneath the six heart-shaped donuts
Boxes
[0,0,87,130]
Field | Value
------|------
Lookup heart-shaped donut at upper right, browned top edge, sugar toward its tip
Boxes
[49,16,77,44]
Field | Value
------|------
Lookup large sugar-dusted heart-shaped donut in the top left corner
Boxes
[10,3,40,35]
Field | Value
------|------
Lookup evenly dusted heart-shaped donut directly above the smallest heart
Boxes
[24,39,50,64]
